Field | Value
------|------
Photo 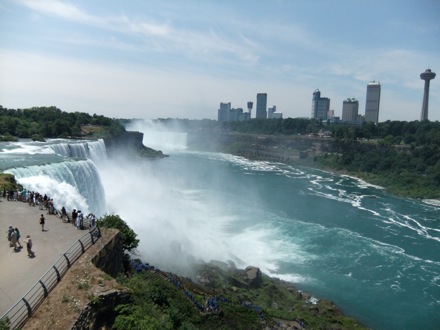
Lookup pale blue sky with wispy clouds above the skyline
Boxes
[0,0,440,121]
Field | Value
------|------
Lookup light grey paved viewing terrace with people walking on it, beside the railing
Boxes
[0,198,87,317]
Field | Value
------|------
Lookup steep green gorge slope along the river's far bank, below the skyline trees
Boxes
[188,132,440,199]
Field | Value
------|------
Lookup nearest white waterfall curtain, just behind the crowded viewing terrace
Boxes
[5,159,106,216]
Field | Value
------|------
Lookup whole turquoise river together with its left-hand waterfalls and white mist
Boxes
[0,128,440,329]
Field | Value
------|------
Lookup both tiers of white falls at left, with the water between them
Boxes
[3,139,107,216]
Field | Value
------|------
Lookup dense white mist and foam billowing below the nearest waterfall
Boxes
[101,155,310,272]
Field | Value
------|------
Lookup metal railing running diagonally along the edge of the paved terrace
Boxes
[0,228,101,329]
